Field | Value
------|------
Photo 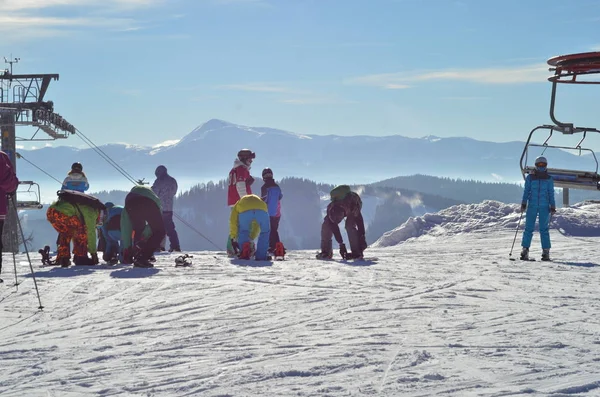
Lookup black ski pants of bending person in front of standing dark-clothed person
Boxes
[125,196,165,260]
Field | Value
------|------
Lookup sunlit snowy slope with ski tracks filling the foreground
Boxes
[0,229,600,397]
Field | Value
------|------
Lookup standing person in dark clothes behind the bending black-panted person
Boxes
[152,165,181,252]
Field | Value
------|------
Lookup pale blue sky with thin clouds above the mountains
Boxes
[0,0,600,145]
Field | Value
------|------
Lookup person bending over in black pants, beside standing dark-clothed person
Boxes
[121,185,165,267]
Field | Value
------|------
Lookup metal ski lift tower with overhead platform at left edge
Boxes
[0,58,76,252]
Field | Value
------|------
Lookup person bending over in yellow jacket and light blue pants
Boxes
[229,194,271,261]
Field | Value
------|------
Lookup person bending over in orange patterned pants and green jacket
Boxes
[46,191,105,267]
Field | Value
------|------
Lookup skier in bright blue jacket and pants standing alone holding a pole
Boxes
[521,156,556,261]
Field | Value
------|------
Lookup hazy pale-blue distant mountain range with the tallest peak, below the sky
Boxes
[18,120,595,201]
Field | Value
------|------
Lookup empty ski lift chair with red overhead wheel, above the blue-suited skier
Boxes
[520,52,600,206]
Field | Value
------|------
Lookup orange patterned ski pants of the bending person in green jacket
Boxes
[46,208,88,260]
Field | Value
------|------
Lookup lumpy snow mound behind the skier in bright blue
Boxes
[371,200,600,247]
